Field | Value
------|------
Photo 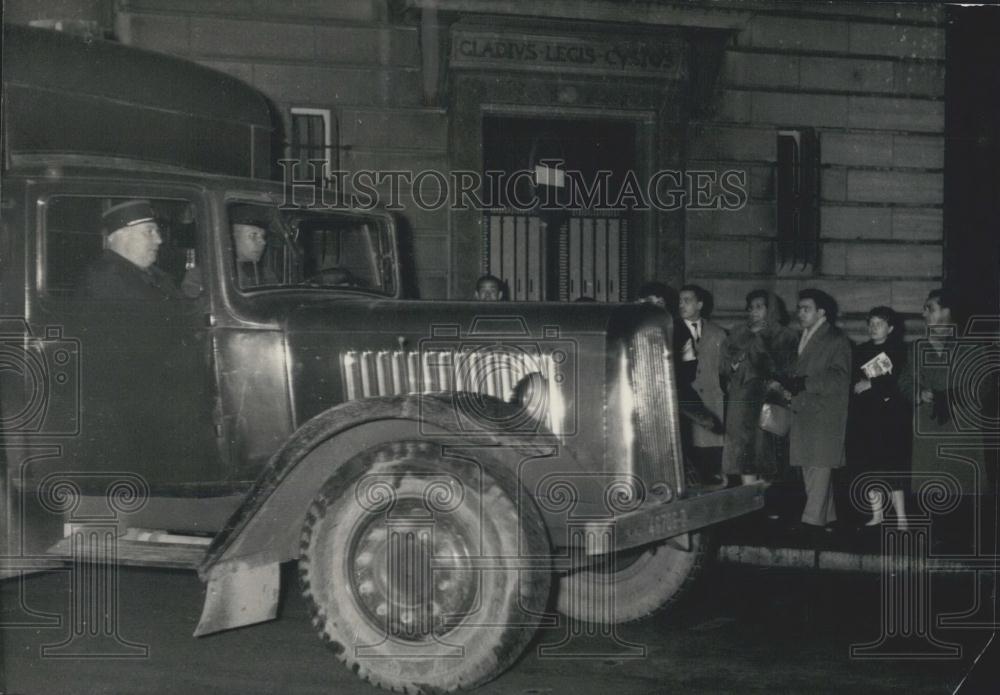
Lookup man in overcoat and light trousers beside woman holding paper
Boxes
[785,289,851,527]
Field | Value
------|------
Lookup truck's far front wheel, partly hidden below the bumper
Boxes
[557,532,709,624]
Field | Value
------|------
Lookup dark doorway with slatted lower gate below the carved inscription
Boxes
[481,115,636,302]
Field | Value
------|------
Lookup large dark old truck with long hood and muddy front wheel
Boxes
[0,26,763,692]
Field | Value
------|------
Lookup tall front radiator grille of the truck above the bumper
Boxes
[629,326,684,493]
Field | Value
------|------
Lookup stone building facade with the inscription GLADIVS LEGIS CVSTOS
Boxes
[8,0,945,328]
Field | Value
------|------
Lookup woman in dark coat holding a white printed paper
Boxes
[848,306,911,527]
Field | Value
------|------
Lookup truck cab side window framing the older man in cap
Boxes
[38,195,201,300]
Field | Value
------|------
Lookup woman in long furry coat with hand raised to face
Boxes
[719,290,798,484]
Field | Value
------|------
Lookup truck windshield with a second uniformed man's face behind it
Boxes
[228,203,395,295]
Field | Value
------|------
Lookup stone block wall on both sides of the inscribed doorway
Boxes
[103,0,945,316]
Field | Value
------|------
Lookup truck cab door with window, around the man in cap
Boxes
[27,182,227,486]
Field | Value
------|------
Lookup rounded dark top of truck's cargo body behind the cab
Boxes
[3,25,275,178]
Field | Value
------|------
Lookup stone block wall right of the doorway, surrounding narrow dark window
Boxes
[686,2,945,336]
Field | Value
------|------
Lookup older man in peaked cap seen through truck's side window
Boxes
[82,200,181,301]
